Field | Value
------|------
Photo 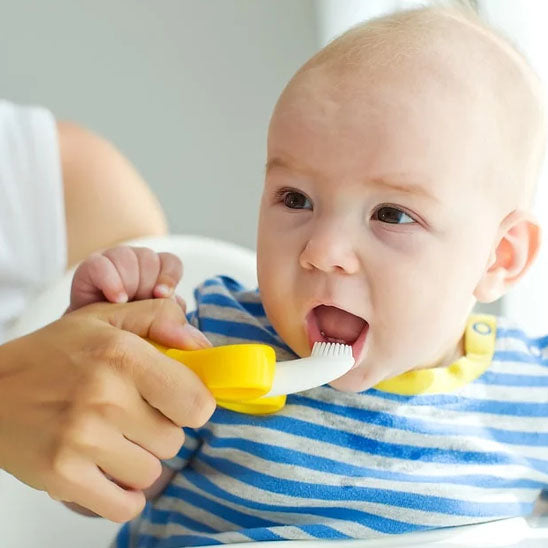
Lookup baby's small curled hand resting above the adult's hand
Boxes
[67,246,184,312]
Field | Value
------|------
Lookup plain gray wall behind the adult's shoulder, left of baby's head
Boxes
[0,0,317,248]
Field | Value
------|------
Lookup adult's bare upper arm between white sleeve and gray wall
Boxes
[58,122,167,265]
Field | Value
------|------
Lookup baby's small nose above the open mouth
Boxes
[299,227,360,274]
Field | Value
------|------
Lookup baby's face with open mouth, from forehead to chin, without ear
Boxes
[258,65,501,391]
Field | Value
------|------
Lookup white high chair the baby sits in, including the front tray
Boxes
[0,235,548,548]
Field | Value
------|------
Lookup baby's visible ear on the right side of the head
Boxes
[474,210,540,303]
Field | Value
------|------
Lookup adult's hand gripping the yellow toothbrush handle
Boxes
[0,299,215,522]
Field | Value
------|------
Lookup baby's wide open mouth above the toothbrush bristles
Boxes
[306,304,369,363]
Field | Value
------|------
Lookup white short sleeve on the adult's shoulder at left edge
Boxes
[0,100,67,342]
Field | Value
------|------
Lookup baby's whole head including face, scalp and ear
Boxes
[258,3,544,391]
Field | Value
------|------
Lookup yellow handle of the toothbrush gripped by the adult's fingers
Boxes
[149,341,285,413]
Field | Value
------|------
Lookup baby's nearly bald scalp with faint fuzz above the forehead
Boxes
[282,6,545,208]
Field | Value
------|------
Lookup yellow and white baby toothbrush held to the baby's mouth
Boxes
[149,341,354,414]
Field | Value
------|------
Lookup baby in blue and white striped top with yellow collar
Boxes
[66,2,548,547]
